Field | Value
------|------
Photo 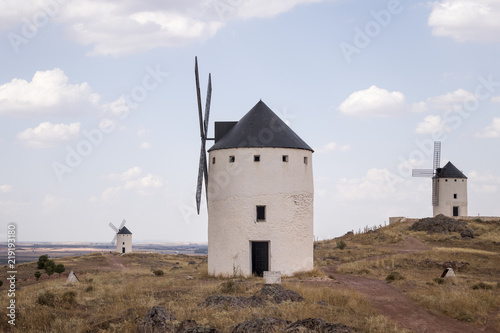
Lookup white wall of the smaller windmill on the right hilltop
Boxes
[433,178,468,216]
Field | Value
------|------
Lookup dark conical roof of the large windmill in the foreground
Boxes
[209,101,313,151]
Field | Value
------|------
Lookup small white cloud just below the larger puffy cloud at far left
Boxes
[17,122,81,148]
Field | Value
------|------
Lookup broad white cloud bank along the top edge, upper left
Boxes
[0,0,323,56]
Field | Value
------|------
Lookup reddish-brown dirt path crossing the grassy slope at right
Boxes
[323,230,497,333]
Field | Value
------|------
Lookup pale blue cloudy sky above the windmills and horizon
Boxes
[0,0,500,242]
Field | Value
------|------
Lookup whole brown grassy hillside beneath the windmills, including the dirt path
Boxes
[0,220,500,333]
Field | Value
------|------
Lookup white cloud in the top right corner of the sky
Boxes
[428,0,500,43]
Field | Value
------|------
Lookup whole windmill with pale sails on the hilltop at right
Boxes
[412,141,468,216]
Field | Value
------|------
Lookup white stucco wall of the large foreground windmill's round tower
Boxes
[208,148,314,275]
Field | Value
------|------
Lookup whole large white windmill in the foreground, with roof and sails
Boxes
[195,56,314,276]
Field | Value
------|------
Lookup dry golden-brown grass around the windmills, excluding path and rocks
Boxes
[0,222,500,333]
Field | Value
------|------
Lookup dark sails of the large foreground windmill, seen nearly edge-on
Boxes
[194,57,214,214]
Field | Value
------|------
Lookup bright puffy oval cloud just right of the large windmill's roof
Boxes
[338,86,408,117]
